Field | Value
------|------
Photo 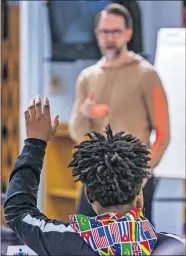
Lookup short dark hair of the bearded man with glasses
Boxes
[95,3,133,29]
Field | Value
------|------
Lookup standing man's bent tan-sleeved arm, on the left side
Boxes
[69,73,91,142]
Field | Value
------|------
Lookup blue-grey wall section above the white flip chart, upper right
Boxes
[138,1,182,63]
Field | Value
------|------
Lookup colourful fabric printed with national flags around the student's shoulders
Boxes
[70,208,157,256]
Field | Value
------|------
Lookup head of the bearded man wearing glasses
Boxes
[95,4,133,60]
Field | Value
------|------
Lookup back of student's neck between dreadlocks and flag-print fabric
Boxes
[98,204,135,216]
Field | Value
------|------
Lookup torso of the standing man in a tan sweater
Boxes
[83,54,151,144]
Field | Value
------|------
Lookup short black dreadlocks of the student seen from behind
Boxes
[69,126,150,207]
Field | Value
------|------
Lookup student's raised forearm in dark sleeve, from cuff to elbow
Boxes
[4,139,46,231]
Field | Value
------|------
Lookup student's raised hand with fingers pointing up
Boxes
[24,97,59,142]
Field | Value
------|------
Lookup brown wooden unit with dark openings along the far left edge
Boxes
[1,1,20,225]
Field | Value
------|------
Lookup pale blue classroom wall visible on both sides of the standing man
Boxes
[20,1,182,235]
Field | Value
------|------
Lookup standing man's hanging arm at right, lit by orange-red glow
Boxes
[142,70,170,168]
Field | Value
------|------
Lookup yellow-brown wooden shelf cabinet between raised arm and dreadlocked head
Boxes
[44,124,81,222]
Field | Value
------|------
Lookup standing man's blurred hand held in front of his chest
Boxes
[81,97,109,119]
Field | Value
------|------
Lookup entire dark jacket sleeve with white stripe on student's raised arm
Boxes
[4,139,83,255]
